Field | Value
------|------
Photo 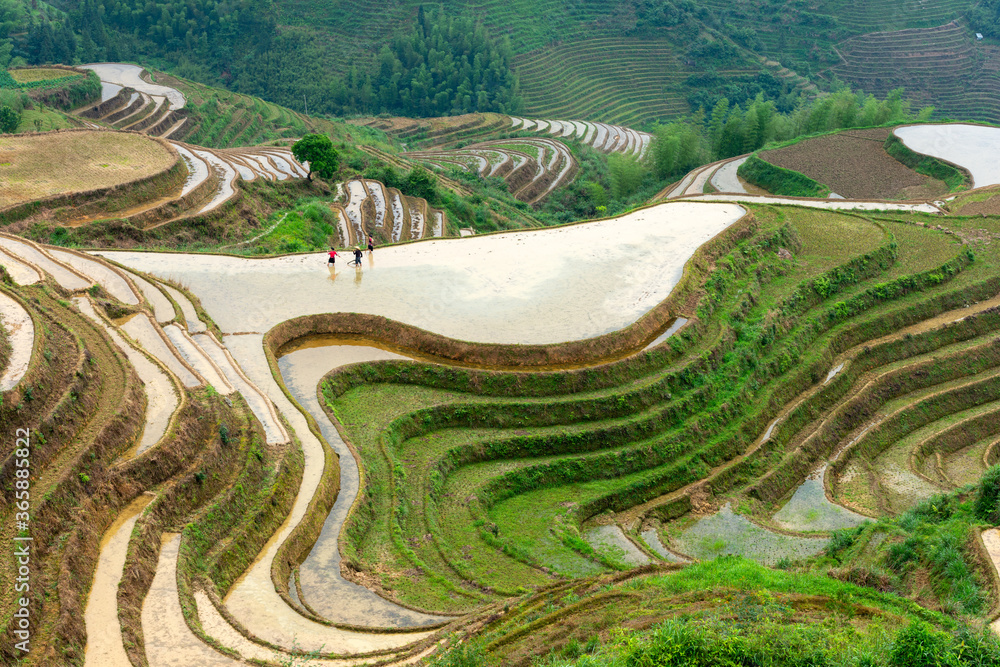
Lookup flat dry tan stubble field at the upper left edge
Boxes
[0,131,177,208]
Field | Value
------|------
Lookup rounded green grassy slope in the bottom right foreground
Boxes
[431,557,1000,667]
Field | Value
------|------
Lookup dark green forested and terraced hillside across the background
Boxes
[0,0,1000,127]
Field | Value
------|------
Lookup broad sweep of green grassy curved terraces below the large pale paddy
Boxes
[302,206,1000,610]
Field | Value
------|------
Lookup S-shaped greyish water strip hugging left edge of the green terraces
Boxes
[278,345,444,627]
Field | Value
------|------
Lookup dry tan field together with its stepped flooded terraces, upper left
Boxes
[0,130,316,235]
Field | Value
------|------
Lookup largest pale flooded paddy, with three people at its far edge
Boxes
[101,202,744,343]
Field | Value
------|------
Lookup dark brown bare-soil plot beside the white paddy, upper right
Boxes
[760,128,948,199]
